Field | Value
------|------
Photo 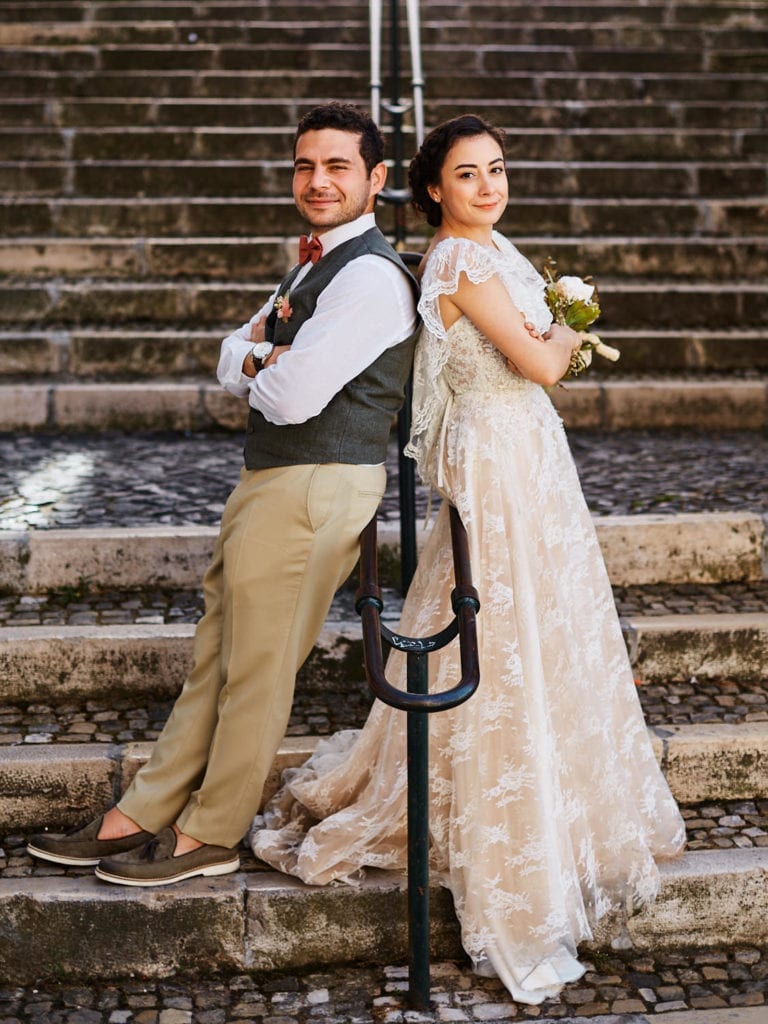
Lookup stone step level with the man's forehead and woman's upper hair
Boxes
[6,125,768,164]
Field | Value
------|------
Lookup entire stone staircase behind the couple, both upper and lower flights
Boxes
[0,0,768,984]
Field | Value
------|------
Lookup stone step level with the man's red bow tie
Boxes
[0,236,768,278]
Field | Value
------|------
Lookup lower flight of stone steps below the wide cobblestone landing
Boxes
[0,513,768,984]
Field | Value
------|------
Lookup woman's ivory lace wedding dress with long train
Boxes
[251,233,685,1004]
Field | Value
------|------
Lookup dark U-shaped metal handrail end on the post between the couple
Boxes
[354,505,480,712]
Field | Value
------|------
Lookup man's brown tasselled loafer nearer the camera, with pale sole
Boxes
[96,826,240,886]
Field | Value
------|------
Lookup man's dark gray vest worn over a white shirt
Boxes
[244,227,419,469]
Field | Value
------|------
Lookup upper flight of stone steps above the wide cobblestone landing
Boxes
[0,0,768,430]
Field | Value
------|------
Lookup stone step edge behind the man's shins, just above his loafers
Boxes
[0,722,768,835]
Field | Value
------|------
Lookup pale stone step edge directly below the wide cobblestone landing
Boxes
[0,512,768,594]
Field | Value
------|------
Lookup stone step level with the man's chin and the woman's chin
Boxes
[0,196,768,241]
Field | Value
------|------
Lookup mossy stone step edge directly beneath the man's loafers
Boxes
[0,849,768,984]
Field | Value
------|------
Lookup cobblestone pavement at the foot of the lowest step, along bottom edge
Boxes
[0,947,768,1024]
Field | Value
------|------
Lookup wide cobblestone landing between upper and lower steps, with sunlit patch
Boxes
[0,431,768,529]
